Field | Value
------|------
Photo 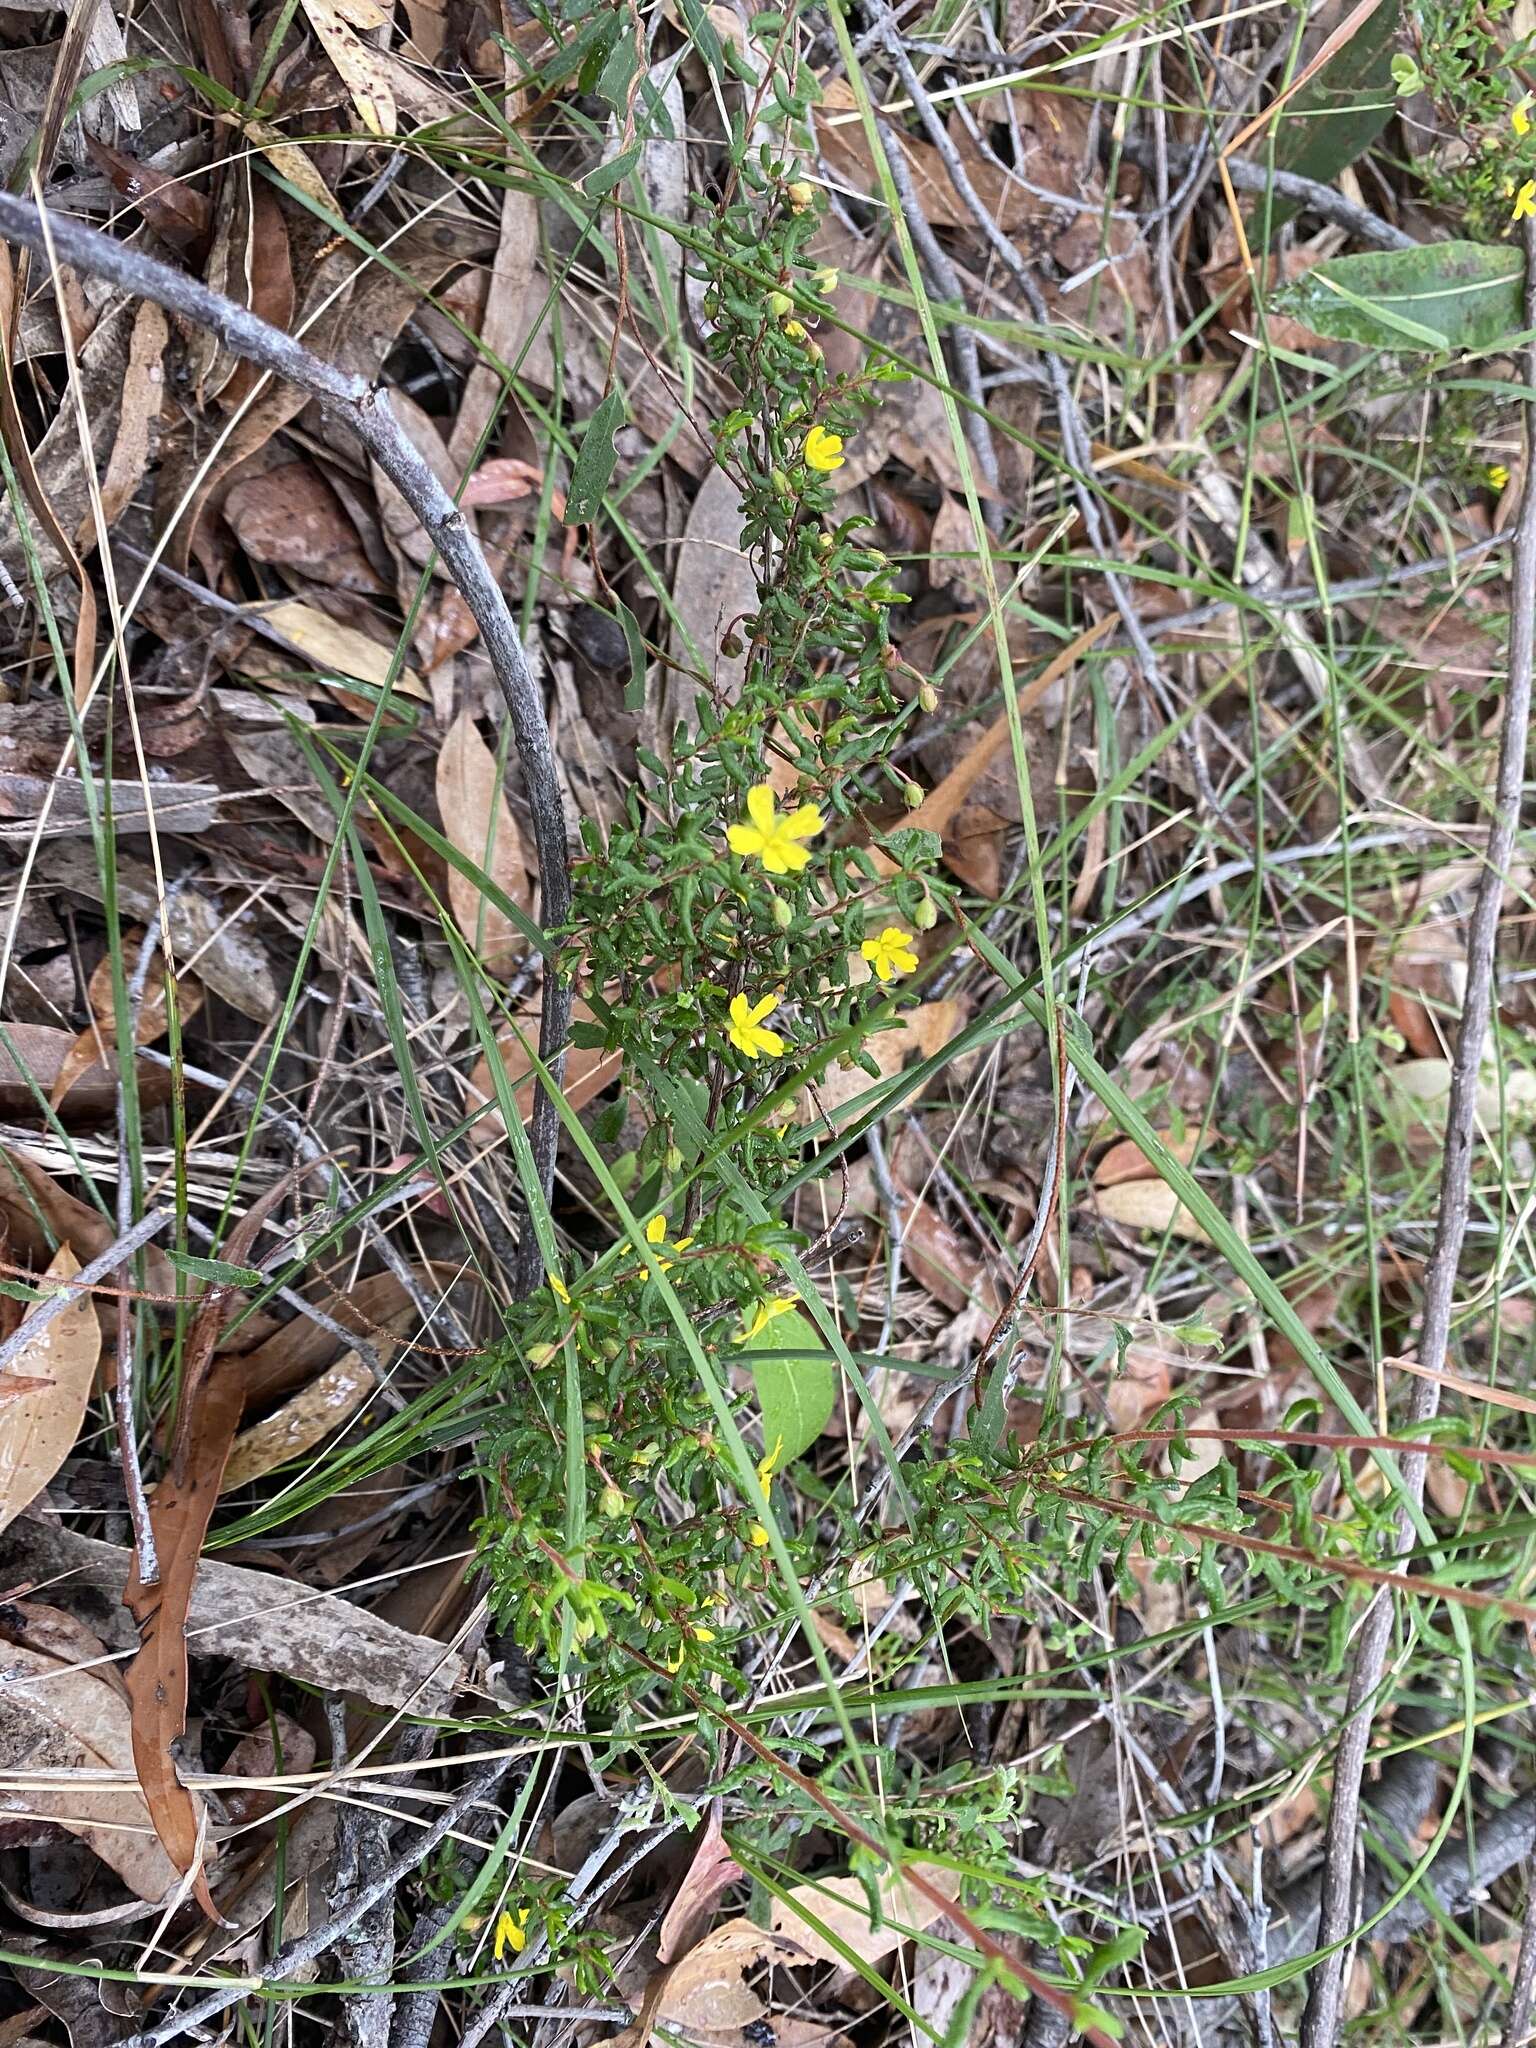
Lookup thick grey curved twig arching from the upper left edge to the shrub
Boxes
[0,193,571,1294]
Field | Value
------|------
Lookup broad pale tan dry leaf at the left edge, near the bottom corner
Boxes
[0,1642,176,1901]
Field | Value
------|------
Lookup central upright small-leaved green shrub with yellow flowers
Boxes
[479,119,946,1706]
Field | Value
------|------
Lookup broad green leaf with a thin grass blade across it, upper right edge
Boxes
[1270,242,1524,352]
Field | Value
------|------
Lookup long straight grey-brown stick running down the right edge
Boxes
[1300,221,1536,2048]
